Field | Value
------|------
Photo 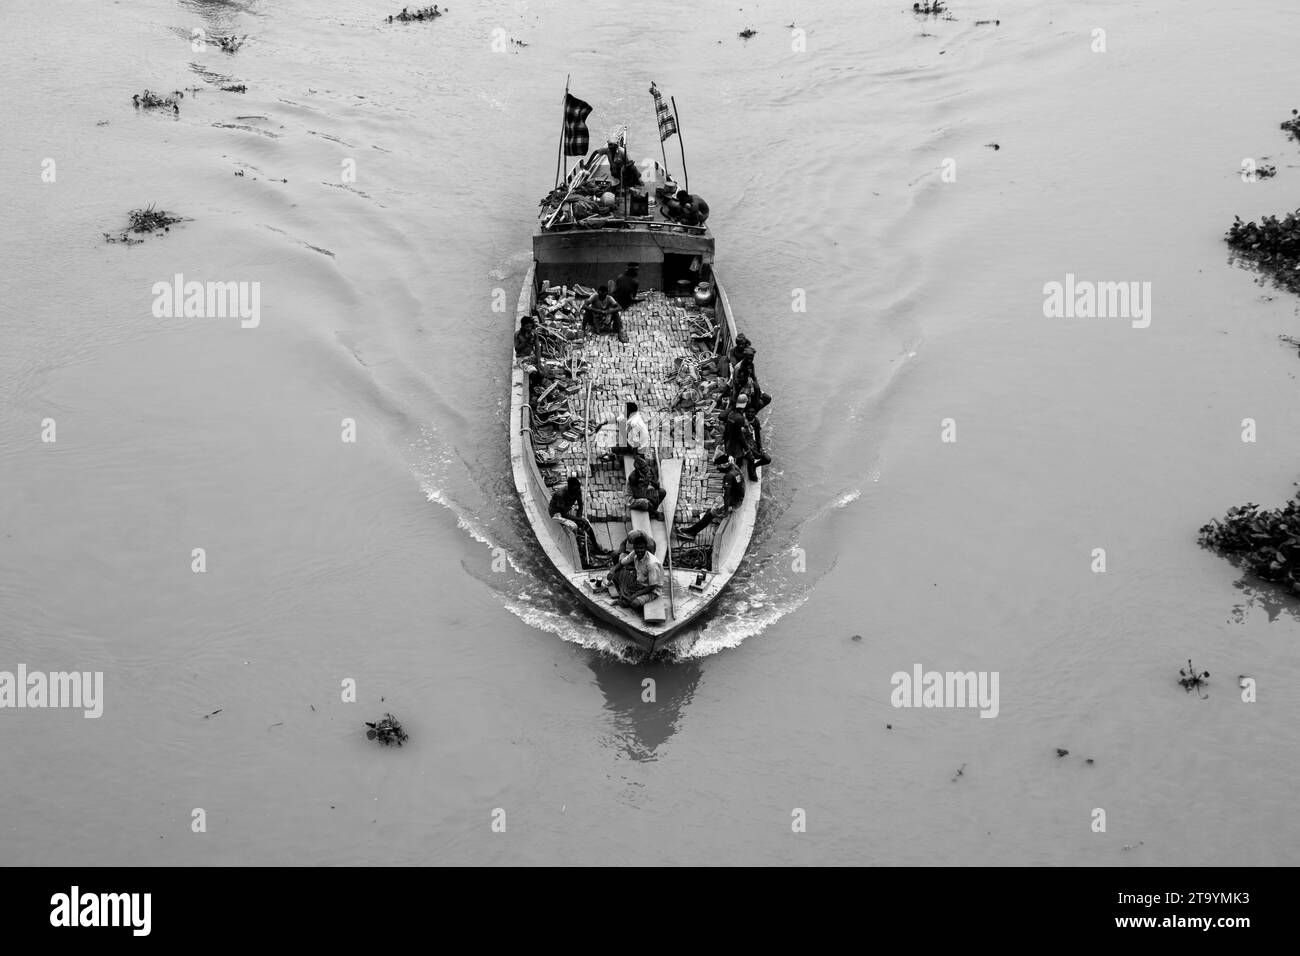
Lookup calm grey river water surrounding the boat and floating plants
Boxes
[0,0,1300,865]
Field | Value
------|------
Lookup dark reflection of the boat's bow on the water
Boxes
[588,654,703,761]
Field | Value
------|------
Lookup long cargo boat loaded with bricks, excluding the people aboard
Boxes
[510,145,762,654]
